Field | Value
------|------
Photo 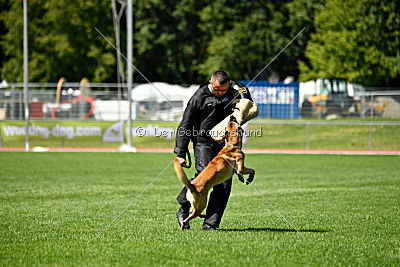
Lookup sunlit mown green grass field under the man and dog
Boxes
[0,152,400,266]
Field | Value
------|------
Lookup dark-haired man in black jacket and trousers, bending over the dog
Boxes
[174,70,251,230]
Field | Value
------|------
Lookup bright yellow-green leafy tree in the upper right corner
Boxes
[299,0,400,86]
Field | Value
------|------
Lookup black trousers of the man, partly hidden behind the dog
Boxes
[176,143,232,228]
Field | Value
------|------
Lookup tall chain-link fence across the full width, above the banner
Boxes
[0,82,400,121]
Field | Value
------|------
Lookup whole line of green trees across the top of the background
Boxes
[0,0,400,86]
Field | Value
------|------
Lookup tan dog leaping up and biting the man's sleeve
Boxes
[174,116,255,231]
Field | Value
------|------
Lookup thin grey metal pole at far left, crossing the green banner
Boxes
[24,0,29,151]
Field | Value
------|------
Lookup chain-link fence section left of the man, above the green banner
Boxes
[0,83,185,121]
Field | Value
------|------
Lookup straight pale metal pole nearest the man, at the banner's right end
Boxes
[126,0,133,147]
